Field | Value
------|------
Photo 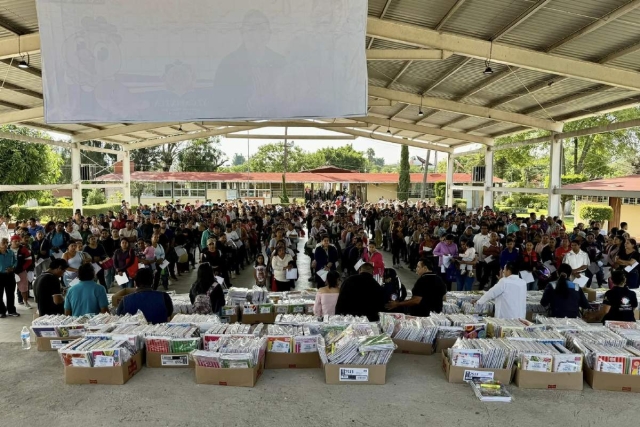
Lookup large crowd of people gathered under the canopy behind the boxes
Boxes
[0,199,640,326]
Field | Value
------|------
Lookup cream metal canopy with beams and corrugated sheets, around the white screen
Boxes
[0,0,640,152]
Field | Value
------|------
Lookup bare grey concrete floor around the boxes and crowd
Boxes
[0,239,638,427]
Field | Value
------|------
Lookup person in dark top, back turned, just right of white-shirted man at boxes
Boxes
[540,264,591,319]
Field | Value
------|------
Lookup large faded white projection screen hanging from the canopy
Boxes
[37,0,367,123]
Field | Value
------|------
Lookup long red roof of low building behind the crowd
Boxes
[95,172,503,184]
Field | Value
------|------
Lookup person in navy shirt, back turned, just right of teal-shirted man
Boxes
[116,268,173,325]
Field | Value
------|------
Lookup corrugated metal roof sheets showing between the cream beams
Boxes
[0,0,640,143]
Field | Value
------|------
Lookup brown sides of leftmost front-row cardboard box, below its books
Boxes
[64,351,142,385]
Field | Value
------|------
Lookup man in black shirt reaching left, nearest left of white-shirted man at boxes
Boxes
[388,261,447,317]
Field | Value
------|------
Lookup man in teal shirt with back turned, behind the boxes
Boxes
[64,264,109,316]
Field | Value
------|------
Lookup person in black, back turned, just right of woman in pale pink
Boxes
[336,263,385,322]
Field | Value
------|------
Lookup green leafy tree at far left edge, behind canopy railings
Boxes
[0,126,62,213]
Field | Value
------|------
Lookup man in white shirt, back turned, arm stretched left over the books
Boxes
[477,262,527,319]
